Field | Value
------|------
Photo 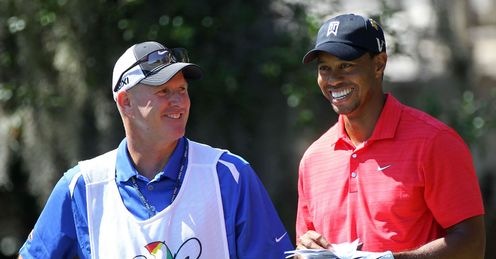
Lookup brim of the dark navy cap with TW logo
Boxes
[302,42,366,64]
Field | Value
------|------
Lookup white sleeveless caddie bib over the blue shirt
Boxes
[80,141,229,259]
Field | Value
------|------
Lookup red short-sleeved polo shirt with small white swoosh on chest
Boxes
[296,95,484,252]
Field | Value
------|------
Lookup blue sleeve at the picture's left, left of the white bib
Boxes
[19,169,79,259]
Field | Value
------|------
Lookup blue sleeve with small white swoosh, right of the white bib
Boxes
[217,153,294,258]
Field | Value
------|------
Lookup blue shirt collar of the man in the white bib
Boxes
[115,137,187,182]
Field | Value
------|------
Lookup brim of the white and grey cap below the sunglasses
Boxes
[140,63,203,86]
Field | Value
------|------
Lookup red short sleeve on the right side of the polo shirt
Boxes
[423,129,484,228]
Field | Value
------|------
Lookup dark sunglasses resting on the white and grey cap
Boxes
[114,48,189,92]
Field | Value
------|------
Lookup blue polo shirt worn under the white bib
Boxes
[19,137,293,259]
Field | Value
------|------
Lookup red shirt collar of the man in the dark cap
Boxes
[332,94,403,144]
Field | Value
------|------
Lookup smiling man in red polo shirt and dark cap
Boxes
[296,14,485,258]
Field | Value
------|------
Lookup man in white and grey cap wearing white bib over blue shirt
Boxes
[20,42,292,259]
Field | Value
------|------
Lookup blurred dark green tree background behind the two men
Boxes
[0,0,496,258]
